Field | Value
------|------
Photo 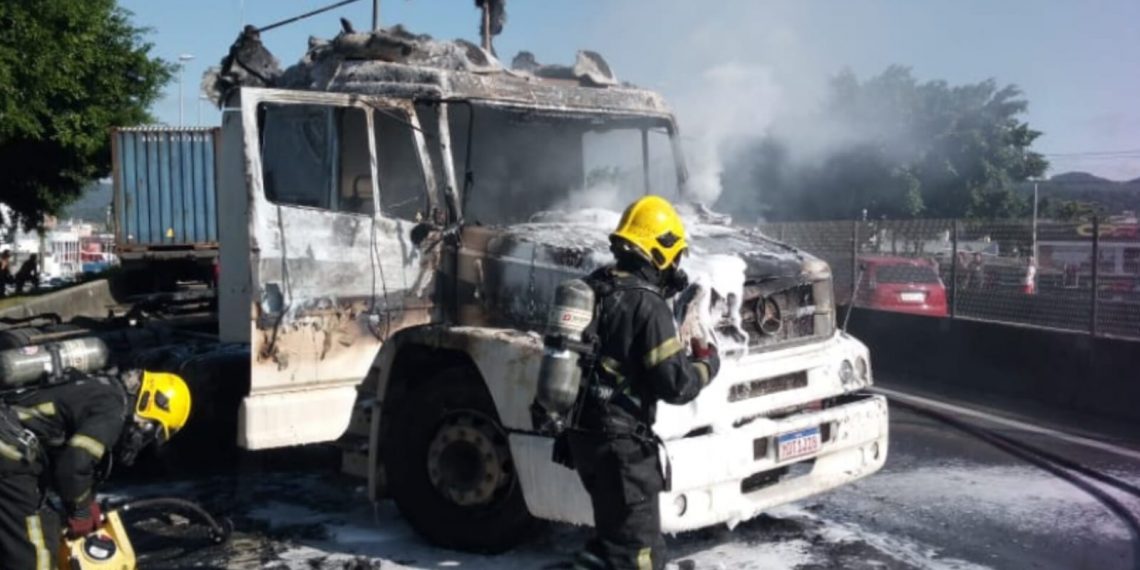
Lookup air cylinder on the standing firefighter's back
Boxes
[535,279,595,422]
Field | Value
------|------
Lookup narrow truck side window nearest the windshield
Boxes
[372,108,428,221]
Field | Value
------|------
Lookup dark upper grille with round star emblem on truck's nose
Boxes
[740,284,822,348]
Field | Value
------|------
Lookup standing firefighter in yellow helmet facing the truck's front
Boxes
[532,196,719,570]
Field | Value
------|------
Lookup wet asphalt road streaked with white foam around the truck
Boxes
[102,387,1140,570]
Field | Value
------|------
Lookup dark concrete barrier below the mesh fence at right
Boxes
[849,309,1140,423]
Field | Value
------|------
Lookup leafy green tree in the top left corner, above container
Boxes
[0,0,173,228]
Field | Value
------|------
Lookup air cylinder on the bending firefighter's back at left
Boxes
[0,336,109,390]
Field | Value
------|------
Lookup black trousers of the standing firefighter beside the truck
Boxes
[570,433,665,570]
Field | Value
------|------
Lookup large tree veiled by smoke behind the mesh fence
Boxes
[719,66,1048,220]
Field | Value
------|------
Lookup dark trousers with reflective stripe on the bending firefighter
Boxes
[0,459,60,570]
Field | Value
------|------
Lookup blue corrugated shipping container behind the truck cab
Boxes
[112,127,221,255]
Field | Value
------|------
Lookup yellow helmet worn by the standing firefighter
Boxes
[610,196,689,269]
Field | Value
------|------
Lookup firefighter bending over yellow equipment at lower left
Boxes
[0,372,190,570]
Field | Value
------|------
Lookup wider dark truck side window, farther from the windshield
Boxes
[261,104,373,214]
